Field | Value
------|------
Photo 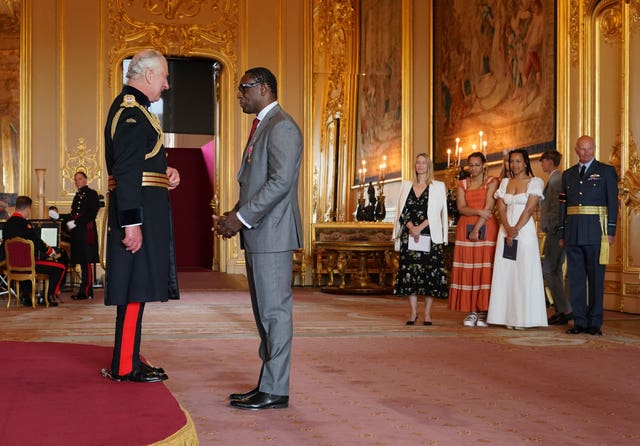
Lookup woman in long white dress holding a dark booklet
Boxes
[487,149,547,329]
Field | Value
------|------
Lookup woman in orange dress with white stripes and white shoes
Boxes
[449,152,498,327]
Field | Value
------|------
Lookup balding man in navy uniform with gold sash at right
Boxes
[560,135,618,335]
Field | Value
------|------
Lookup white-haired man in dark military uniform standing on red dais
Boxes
[102,50,180,382]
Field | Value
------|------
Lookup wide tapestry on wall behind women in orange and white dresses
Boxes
[432,0,556,169]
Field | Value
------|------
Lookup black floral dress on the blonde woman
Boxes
[393,187,449,299]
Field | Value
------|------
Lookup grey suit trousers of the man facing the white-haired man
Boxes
[245,251,293,395]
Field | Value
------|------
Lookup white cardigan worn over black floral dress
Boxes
[392,180,449,250]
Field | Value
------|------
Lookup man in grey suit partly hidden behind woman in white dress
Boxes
[540,150,572,325]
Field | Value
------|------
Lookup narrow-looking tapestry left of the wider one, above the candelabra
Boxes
[353,0,404,185]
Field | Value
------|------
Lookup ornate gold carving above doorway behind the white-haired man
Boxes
[108,0,240,79]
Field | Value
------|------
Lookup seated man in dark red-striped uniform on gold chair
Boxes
[0,195,65,307]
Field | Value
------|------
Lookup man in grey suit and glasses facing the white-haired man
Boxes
[214,68,302,410]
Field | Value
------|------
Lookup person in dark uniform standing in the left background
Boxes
[66,171,100,300]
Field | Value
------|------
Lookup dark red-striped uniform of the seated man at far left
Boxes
[0,212,66,302]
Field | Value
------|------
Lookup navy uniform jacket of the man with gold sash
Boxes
[560,160,618,245]
